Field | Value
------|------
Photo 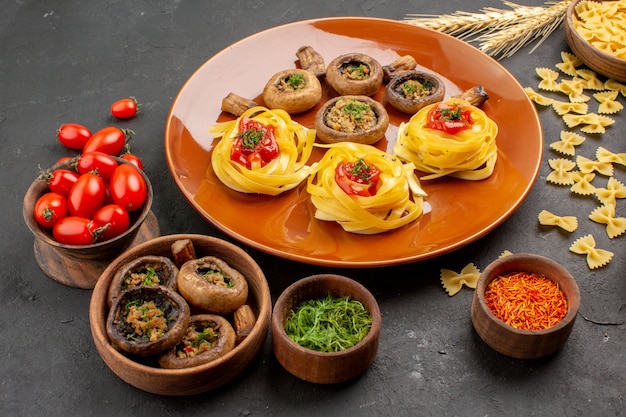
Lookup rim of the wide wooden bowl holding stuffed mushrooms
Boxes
[89,234,272,378]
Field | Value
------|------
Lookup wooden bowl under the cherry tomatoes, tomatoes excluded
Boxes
[22,157,160,289]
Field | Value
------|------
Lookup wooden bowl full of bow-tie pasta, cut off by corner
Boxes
[564,0,626,82]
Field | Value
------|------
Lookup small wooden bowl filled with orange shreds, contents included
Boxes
[471,254,580,359]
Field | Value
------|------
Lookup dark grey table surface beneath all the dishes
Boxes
[0,0,626,416]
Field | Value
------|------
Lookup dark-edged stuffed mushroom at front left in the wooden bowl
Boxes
[106,285,190,356]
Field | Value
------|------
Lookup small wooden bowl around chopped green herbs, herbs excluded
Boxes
[272,274,381,384]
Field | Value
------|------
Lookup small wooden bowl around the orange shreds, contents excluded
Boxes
[471,254,580,359]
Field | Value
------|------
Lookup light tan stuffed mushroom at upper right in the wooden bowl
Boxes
[177,256,248,314]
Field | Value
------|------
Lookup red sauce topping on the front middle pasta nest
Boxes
[335,159,380,197]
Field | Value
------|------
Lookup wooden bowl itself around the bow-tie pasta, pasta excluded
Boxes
[565,0,626,82]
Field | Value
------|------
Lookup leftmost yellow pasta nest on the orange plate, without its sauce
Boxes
[209,106,315,196]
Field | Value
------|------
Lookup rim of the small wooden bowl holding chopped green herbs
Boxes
[272,274,382,358]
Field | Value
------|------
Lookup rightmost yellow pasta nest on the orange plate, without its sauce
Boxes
[393,99,498,180]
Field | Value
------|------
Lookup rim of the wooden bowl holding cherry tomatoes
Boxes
[22,156,154,247]
